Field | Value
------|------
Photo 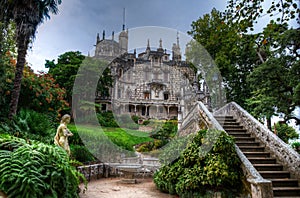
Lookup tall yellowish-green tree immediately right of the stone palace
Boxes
[189,9,258,106]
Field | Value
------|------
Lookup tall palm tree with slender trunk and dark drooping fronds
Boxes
[0,0,61,118]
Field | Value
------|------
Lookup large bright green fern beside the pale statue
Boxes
[0,136,86,198]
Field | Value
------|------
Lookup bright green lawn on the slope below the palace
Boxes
[68,124,153,151]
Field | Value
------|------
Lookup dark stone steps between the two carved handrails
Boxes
[215,116,300,197]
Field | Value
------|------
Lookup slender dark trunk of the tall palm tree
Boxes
[8,34,29,119]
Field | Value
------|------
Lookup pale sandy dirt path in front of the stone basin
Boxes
[80,178,178,198]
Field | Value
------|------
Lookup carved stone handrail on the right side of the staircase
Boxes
[214,102,300,180]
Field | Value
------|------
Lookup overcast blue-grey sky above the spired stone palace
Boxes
[27,0,226,72]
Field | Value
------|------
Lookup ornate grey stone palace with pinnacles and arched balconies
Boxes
[95,30,210,120]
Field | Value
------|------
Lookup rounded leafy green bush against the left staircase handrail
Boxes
[154,131,242,196]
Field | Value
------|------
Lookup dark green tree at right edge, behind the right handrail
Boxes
[248,23,300,128]
